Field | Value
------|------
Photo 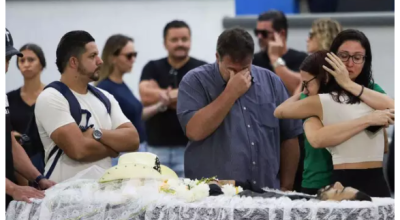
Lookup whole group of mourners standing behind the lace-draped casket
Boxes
[6,10,394,210]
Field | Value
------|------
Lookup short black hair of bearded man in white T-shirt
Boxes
[56,31,95,74]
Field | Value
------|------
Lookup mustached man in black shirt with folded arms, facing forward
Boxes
[139,21,205,177]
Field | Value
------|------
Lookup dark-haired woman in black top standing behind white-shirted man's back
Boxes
[7,44,46,185]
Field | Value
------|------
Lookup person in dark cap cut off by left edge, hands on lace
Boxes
[5,29,55,209]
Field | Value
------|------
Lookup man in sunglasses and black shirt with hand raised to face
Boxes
[253,10,307,95]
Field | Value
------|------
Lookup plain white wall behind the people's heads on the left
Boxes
[6,0,235,97]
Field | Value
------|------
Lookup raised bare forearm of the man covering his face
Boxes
[186,90,236,141]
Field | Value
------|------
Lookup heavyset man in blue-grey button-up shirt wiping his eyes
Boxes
[177,28,302,190]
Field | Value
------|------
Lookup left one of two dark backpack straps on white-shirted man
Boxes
[44,81,82,179]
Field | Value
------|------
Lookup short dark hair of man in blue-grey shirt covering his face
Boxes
[217,28,254,62]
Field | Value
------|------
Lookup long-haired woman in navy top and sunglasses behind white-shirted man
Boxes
[96,34,169,165]
